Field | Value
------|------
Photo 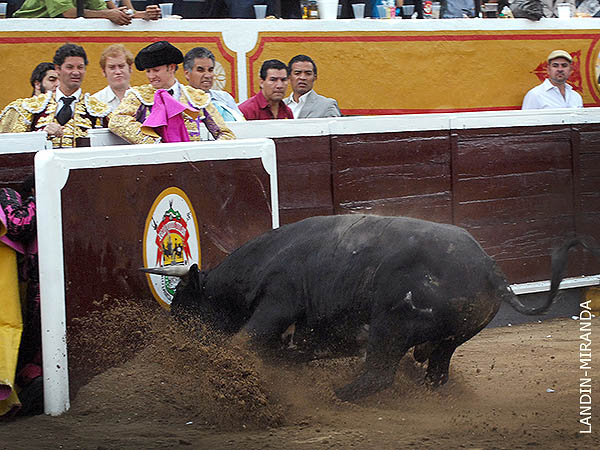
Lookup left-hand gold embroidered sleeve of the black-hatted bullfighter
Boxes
[108,91,160,144]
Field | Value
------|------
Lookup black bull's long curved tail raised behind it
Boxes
[503,236,600,315]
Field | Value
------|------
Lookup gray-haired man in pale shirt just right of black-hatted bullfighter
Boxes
[183,47,244,122]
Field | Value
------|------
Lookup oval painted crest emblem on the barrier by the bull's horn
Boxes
[144,187,200,309]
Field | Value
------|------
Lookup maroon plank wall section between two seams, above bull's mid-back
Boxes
[332,131,452,223]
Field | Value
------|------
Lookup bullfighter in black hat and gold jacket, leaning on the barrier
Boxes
[109,41,235,144]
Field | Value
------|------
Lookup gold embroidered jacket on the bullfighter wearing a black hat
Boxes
[108,84,235,144]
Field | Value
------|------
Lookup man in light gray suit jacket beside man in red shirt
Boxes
[283,55,342,119]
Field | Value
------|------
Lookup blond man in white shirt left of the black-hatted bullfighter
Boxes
[93,44,133,112]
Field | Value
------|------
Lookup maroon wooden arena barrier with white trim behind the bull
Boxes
[0,108,600,411]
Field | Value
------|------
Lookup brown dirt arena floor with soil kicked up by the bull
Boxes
[0,302,600,450]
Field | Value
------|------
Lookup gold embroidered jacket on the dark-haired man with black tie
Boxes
[0,92,110,148]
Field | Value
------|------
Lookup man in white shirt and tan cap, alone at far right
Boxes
[521,50,583,109]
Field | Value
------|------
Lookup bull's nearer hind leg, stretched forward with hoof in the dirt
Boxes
[335,321,410,401]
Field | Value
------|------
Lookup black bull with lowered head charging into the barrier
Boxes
[145,215,587,400]
